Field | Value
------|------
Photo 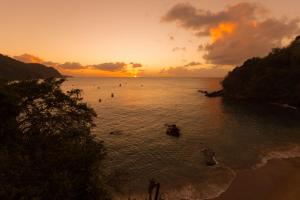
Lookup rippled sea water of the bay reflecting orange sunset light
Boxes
[63,78,300,200]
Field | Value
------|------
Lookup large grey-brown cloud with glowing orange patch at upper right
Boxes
[162,3,300,65]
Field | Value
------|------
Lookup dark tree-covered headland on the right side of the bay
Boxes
[222,36,300,107]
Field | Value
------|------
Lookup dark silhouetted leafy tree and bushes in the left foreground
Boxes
[0,79,109,200]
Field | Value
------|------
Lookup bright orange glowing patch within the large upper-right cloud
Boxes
[209,22,237,42]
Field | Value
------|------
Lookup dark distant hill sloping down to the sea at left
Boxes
[0,54,64,80]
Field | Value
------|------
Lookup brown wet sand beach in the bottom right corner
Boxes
[214,158,300,200]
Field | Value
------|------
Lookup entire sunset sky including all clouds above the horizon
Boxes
[0,0,300,77]
